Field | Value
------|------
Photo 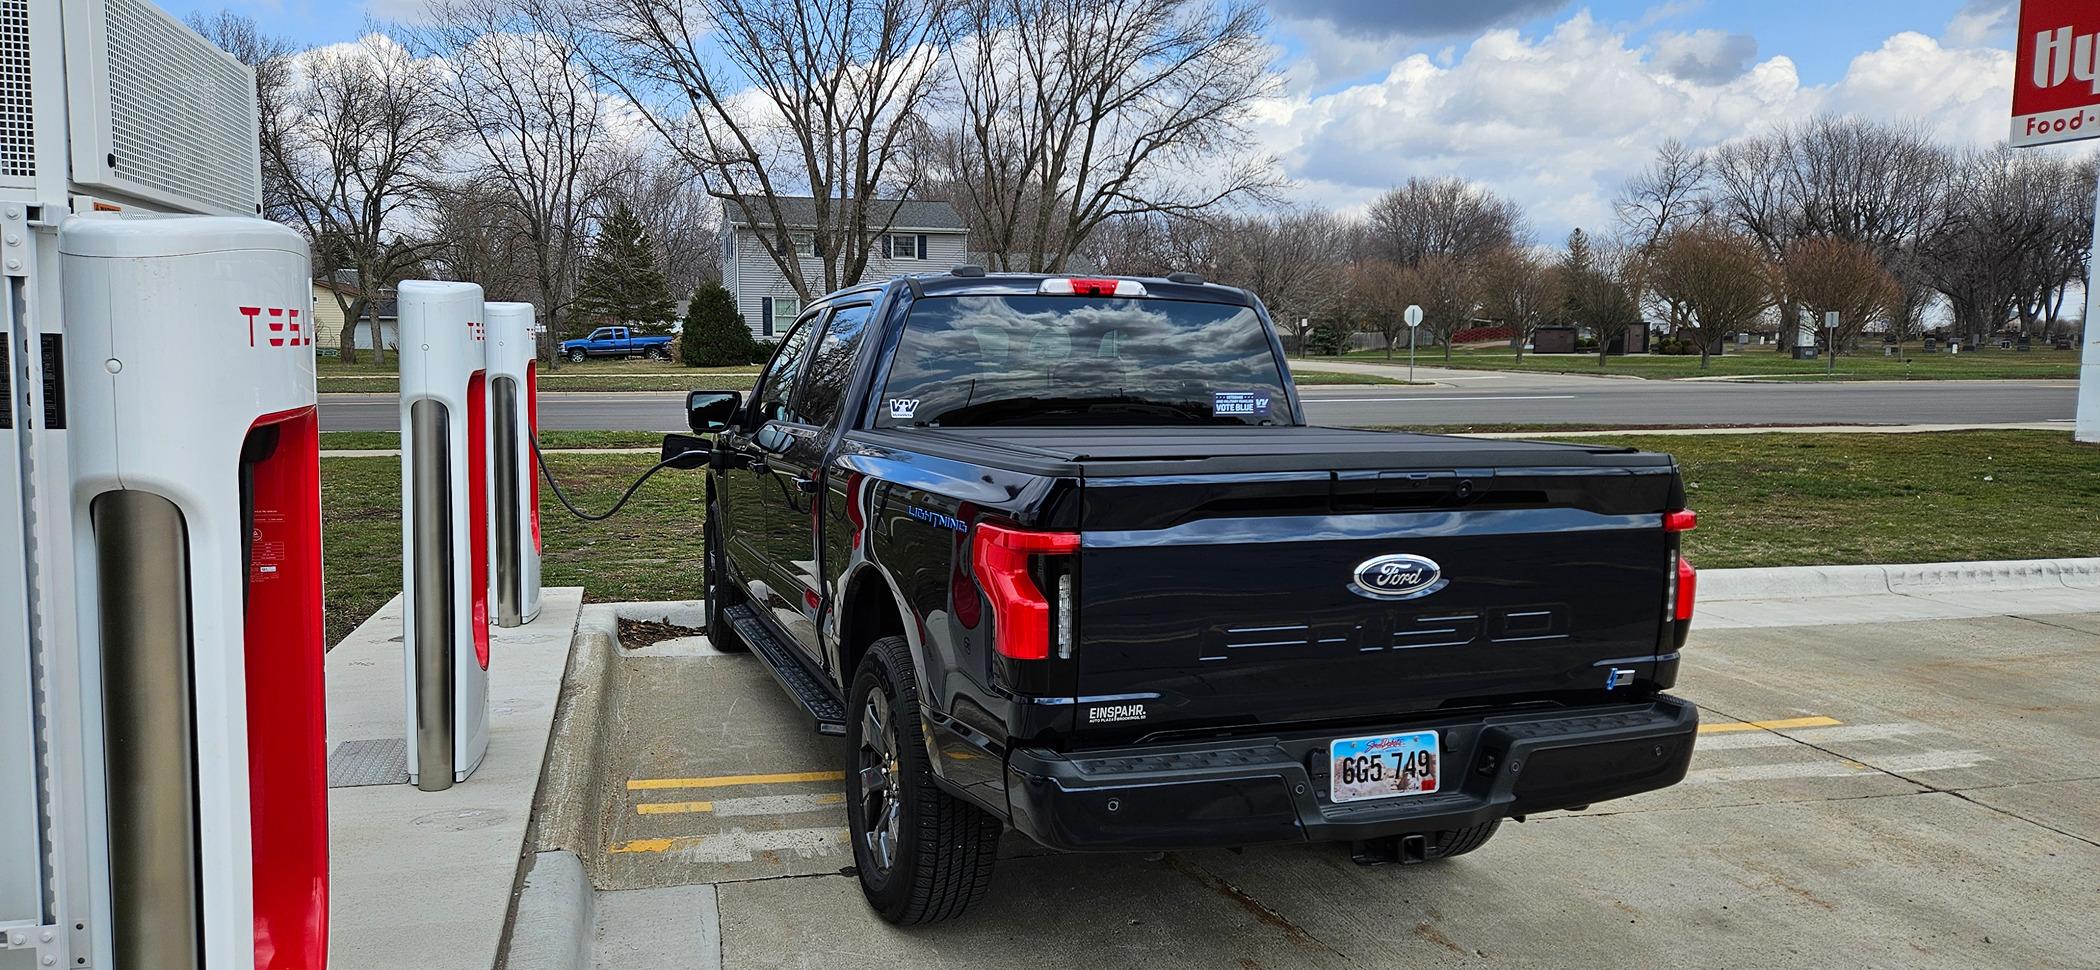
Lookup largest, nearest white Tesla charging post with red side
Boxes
[59,216,328,970]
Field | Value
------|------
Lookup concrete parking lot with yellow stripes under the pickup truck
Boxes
[557,605,2100,970]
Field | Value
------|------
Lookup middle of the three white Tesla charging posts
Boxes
[399,279,489,792]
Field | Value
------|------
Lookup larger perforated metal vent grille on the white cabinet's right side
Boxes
[100,0,263,212]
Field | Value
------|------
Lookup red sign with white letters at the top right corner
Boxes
[2012,0,2100,145]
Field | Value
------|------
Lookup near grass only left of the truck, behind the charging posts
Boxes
[321,454,706,642]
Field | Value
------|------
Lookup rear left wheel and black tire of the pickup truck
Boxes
[846,636,1000,926]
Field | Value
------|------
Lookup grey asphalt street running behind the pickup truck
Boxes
[321,367,2077,430]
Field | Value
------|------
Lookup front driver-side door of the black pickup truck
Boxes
[716,315,817,632]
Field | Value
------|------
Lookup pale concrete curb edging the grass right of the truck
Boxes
[1699,556,2100,605]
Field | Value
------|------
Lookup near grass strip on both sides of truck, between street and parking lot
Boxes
[321,430,2100,642]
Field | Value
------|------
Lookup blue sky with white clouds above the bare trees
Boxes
[160,0,2014,241]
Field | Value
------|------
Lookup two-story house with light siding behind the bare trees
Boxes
[722,197,970,340]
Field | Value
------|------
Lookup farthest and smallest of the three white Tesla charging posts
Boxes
[483,302,540,626]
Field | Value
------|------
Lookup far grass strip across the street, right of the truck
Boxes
[1313,342,2079,380]
